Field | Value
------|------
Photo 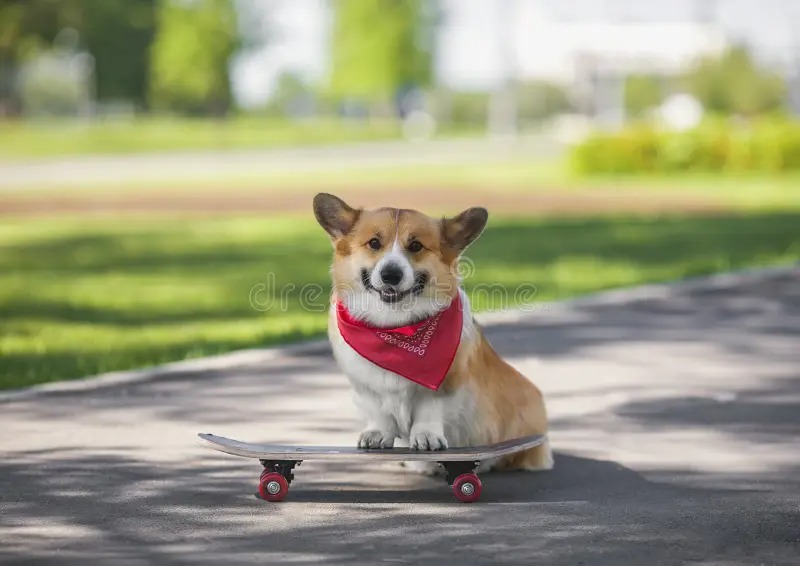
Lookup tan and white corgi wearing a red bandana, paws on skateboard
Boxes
[314,193,553,473]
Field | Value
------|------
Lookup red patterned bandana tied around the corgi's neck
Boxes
[336,296,462,391]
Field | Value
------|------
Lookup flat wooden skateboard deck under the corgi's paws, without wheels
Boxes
[197,433,545,462]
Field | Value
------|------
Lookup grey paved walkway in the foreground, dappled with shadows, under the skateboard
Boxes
[0,268,800,566]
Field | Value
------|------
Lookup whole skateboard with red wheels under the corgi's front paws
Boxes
[198,434,545,503]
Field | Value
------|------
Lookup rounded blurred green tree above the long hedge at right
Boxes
[686,46,786,116]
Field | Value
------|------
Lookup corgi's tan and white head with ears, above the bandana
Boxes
[314,193,488,327]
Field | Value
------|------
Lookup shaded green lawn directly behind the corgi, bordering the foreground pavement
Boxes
[0,211,800,389]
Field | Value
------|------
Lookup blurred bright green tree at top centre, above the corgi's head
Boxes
[331,0,436,106]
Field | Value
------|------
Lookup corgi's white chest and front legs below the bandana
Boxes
[330,295,474,449]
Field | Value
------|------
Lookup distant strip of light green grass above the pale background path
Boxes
[0,116,400,159]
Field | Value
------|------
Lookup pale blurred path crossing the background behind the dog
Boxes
[0,135,561,191]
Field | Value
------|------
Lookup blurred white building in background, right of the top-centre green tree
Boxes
[438,0,728,89]
